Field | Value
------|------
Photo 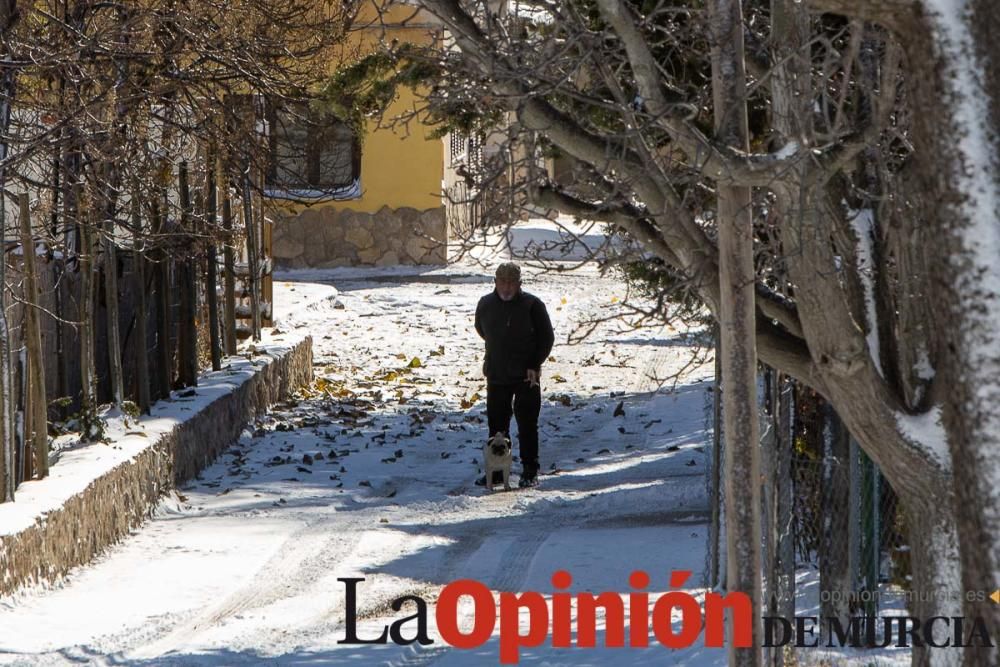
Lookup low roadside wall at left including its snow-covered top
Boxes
[0,337,313,595]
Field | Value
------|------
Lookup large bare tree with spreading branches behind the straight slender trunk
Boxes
[350,0,997,664]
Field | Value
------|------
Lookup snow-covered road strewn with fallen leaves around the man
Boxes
[0,264,725,667]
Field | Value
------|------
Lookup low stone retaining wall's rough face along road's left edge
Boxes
[0,338,313,595]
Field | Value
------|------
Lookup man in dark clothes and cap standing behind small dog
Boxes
[476,262,555,487]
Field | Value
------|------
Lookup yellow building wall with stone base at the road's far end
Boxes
[270,0,449,269]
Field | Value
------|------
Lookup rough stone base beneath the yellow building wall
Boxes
[272,206,448,269]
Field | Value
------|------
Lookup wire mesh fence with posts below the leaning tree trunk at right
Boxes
[704,374,911,636]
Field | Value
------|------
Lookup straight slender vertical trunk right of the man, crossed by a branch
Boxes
[709,0,762,665]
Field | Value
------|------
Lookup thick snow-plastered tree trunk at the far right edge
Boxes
[908,0,1000,666]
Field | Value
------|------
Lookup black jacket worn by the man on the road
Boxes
[476,291,555,384]
